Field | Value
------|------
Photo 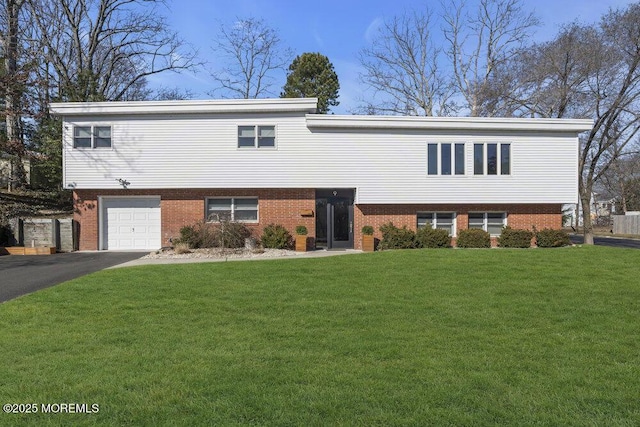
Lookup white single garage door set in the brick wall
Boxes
[102,197,162,250]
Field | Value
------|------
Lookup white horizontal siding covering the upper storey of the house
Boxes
[58,113,578,204]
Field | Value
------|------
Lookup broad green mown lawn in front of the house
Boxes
[0,247,640,426]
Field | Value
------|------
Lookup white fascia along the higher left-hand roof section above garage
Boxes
[49,98,318,116]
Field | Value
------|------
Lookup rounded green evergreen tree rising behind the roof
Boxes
[280,53,340,114]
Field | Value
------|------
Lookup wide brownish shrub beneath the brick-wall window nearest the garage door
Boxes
[174,221,251,249]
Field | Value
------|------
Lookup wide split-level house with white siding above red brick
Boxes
[51,99,592,250]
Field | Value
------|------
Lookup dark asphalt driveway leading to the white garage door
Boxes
[0,252,147,303]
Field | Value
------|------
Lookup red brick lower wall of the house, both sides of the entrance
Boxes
[74,188,562,250]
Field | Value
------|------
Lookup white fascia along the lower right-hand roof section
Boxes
[306,114,593,133]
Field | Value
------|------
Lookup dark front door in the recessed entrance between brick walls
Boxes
[316,190,353,249]
